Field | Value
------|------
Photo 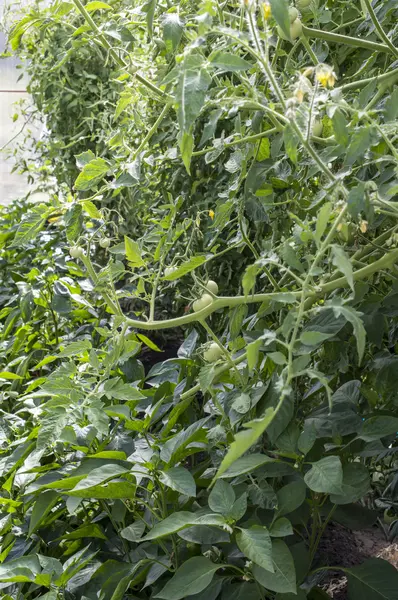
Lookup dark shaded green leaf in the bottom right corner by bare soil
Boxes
[344,558,398,600]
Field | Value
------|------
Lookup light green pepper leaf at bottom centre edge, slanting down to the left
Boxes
[154,556,223,600]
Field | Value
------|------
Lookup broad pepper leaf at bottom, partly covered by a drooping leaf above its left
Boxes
[252,539,297,594]
